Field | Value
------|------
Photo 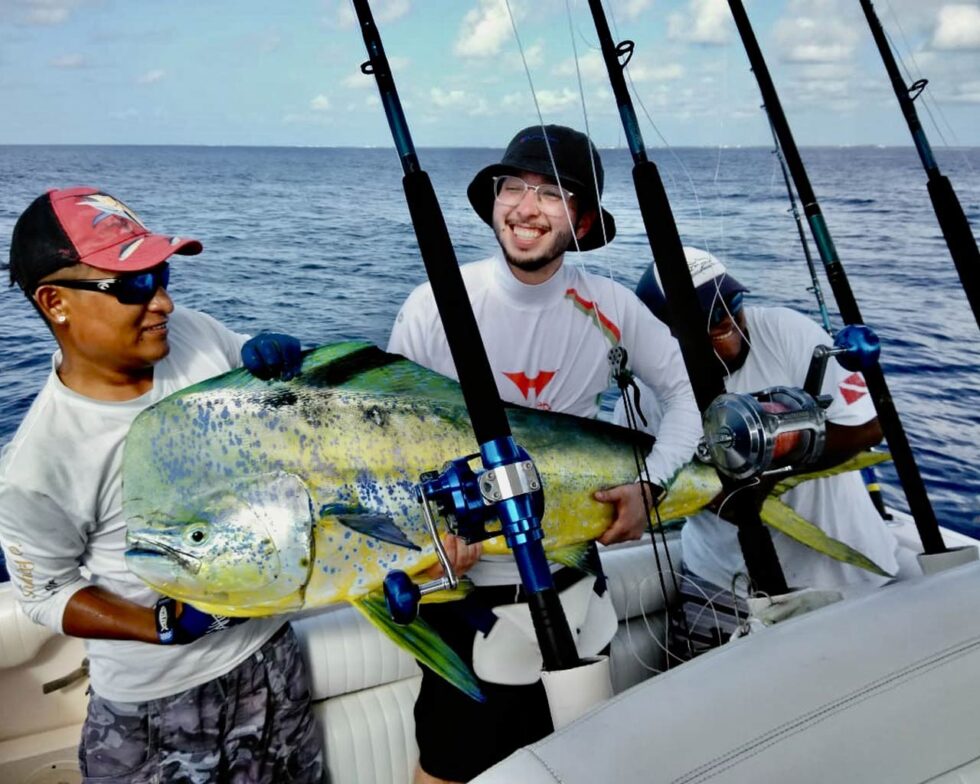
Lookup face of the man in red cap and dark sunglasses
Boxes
[35,264,174,399]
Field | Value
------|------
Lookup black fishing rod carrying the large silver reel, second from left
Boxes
[589,0,788,595]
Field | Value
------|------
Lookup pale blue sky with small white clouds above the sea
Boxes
[0,0,980,147]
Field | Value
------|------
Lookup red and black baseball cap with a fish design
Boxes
[10,188,203,297]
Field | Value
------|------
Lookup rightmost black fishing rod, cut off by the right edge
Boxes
[861,0,980,326]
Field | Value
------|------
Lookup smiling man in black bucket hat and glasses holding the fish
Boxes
[388,125,700,782]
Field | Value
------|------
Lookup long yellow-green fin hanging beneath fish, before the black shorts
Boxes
[352,591,486,702]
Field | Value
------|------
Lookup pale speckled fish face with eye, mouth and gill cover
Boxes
[126,471,313,615]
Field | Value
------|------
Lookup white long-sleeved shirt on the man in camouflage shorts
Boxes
[0,308,283,702]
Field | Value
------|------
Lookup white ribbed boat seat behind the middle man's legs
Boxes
[293,539,680,784]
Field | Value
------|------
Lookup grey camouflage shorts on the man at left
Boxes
[78,624,324,784]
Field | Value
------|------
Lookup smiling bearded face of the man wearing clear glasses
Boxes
[493,172,594,283]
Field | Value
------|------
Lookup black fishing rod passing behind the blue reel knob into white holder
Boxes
[728,0,946,554]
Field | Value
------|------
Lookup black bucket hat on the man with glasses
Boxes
[466,125,616,251]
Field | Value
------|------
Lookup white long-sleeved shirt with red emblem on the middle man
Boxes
[388,254,701,585]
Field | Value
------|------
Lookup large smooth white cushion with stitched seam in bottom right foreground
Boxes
[474,563,980,784]
